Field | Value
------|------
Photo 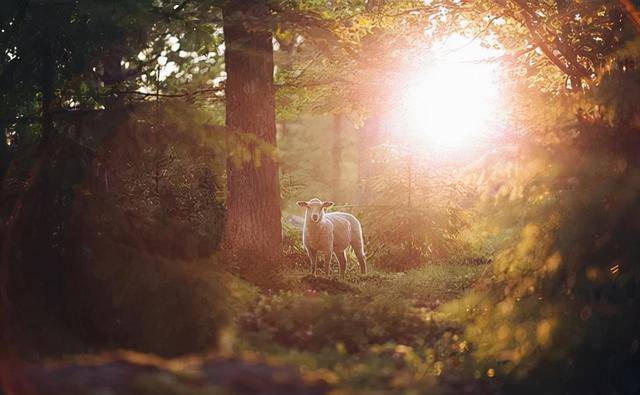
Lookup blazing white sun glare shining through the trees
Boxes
[400,36,499,149]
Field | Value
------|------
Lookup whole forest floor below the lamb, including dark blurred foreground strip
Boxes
[15,264,498,395]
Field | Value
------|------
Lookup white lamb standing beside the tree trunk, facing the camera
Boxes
[298,198,367,277]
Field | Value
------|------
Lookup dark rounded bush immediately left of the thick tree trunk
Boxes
[79,105,224,259]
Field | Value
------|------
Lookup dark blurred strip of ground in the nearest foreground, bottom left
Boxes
[2,351,330,395]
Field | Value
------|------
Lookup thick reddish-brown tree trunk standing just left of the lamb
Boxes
[223,0,282,267]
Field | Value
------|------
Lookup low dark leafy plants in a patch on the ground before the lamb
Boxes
[240,291,440,353]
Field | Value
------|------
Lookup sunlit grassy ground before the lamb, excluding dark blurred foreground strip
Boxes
[228,265,495,394]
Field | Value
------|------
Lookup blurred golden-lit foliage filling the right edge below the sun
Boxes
[442,36,640,392]
